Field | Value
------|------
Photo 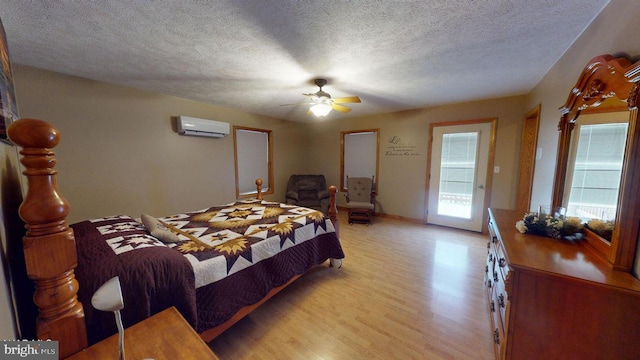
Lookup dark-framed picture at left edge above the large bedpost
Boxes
[0,20,18,144]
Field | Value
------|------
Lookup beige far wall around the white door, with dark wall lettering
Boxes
[309,97,526,220]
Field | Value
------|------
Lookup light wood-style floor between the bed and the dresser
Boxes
[210,212,494,360]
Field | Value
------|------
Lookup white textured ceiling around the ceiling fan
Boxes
[0,0,608,121]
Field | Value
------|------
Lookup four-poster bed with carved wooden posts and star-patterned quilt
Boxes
[9,119,344,358]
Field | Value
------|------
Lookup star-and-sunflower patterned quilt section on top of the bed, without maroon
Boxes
[159,200,342,288]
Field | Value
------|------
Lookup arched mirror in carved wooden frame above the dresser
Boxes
[552,55,640,271]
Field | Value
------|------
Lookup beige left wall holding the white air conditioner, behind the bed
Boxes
[14,65,306,222]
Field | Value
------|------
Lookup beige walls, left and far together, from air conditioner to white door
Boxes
[14,65,524,222]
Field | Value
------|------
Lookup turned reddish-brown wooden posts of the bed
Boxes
[8,119,338,359]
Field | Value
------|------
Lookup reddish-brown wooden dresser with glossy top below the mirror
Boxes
[484,209,640,360]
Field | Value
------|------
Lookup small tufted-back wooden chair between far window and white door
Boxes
[346,176,375,224]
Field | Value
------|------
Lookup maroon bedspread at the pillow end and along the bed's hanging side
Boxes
[71,210,344,344]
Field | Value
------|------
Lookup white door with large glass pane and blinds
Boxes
[427,122,492,231]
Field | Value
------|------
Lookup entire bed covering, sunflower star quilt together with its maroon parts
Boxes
[70,200,344,338]
